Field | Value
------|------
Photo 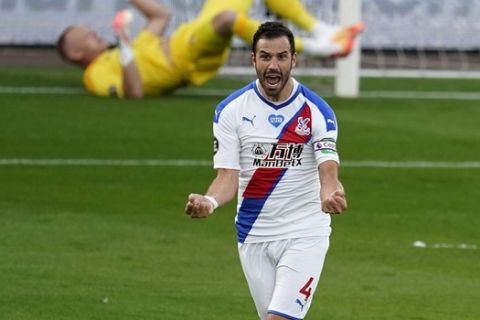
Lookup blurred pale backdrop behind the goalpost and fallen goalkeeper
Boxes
[0,0,480,77]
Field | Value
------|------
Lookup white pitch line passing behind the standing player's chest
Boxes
[0,158,480,169]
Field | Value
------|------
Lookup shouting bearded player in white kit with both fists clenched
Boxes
[185,22,347,320]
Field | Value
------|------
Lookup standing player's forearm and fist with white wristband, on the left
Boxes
[185,168,238,218]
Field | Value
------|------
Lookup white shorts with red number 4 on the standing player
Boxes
[238,237,330,320]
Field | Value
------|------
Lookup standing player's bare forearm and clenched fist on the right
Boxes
[318,160,347,214]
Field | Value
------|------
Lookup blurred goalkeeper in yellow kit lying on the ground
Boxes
[57,0,363,98]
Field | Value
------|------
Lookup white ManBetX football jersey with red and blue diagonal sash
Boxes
[213,79,339,243]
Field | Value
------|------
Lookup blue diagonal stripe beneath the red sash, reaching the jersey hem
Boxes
[235,168,287,243]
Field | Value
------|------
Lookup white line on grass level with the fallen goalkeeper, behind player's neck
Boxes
[0,86,480,100]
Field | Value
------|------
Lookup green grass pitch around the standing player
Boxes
[0,67,480,320]
